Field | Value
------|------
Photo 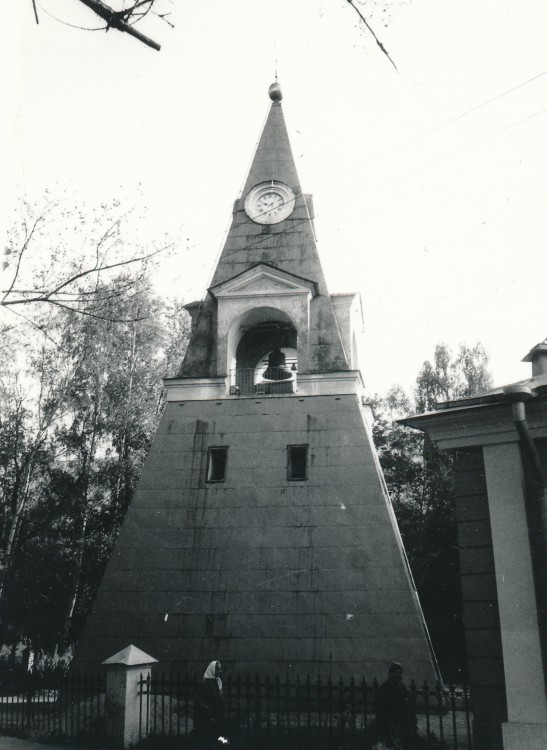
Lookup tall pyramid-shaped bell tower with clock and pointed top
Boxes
[77,84,434,679]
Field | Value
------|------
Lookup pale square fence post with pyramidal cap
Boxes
[102,646,158,748]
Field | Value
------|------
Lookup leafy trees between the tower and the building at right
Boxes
[372,344,491,680]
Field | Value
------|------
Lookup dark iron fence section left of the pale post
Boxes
[0,672,106,739]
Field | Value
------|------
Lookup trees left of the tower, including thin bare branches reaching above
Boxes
[0,191,188,643]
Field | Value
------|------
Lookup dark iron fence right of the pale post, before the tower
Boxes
[140,675,473,750]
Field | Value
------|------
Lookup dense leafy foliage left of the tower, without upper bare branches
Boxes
[0,270,187,649]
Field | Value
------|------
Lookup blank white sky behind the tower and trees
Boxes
[2,0,547,392]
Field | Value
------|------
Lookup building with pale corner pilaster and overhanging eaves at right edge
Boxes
[404,341,547,750]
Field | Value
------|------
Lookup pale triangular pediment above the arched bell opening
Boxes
[209,263,317,298]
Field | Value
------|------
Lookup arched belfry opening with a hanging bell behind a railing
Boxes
[230,308,298,396]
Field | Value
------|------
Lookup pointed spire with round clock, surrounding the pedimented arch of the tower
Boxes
[181,81,348,377]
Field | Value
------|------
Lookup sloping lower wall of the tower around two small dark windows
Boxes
[77,395,434,680]
